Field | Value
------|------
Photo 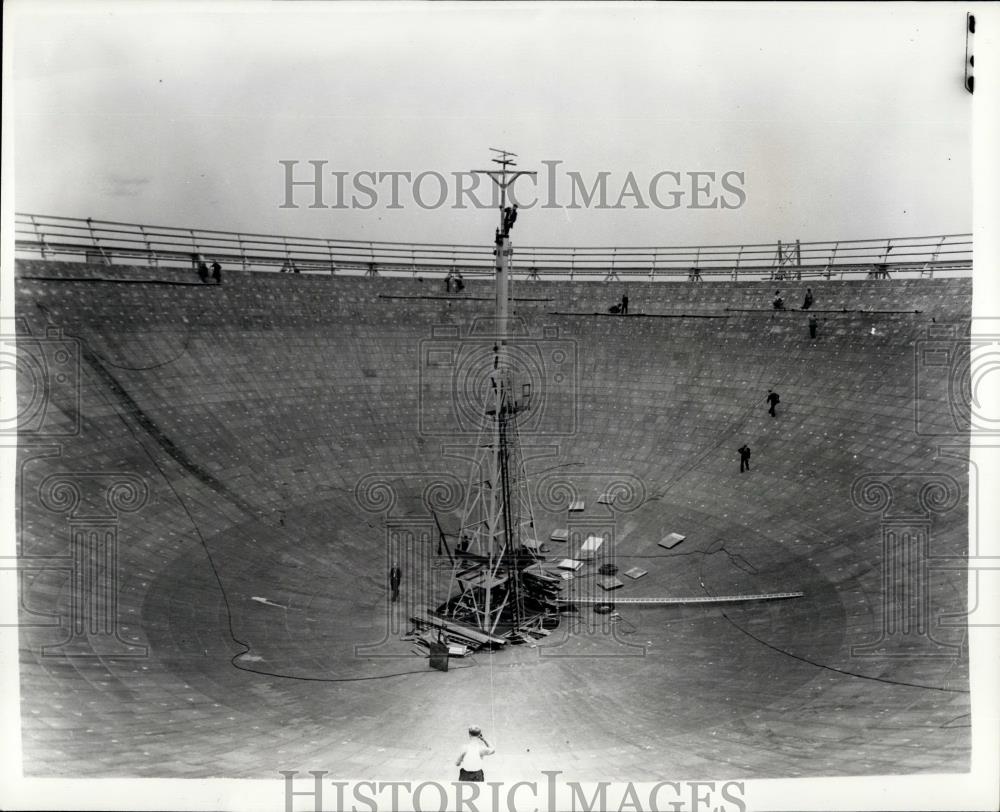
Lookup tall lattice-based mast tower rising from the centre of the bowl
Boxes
[438,150,554,643]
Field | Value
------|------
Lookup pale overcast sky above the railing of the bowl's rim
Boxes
[7,2,972,245]
